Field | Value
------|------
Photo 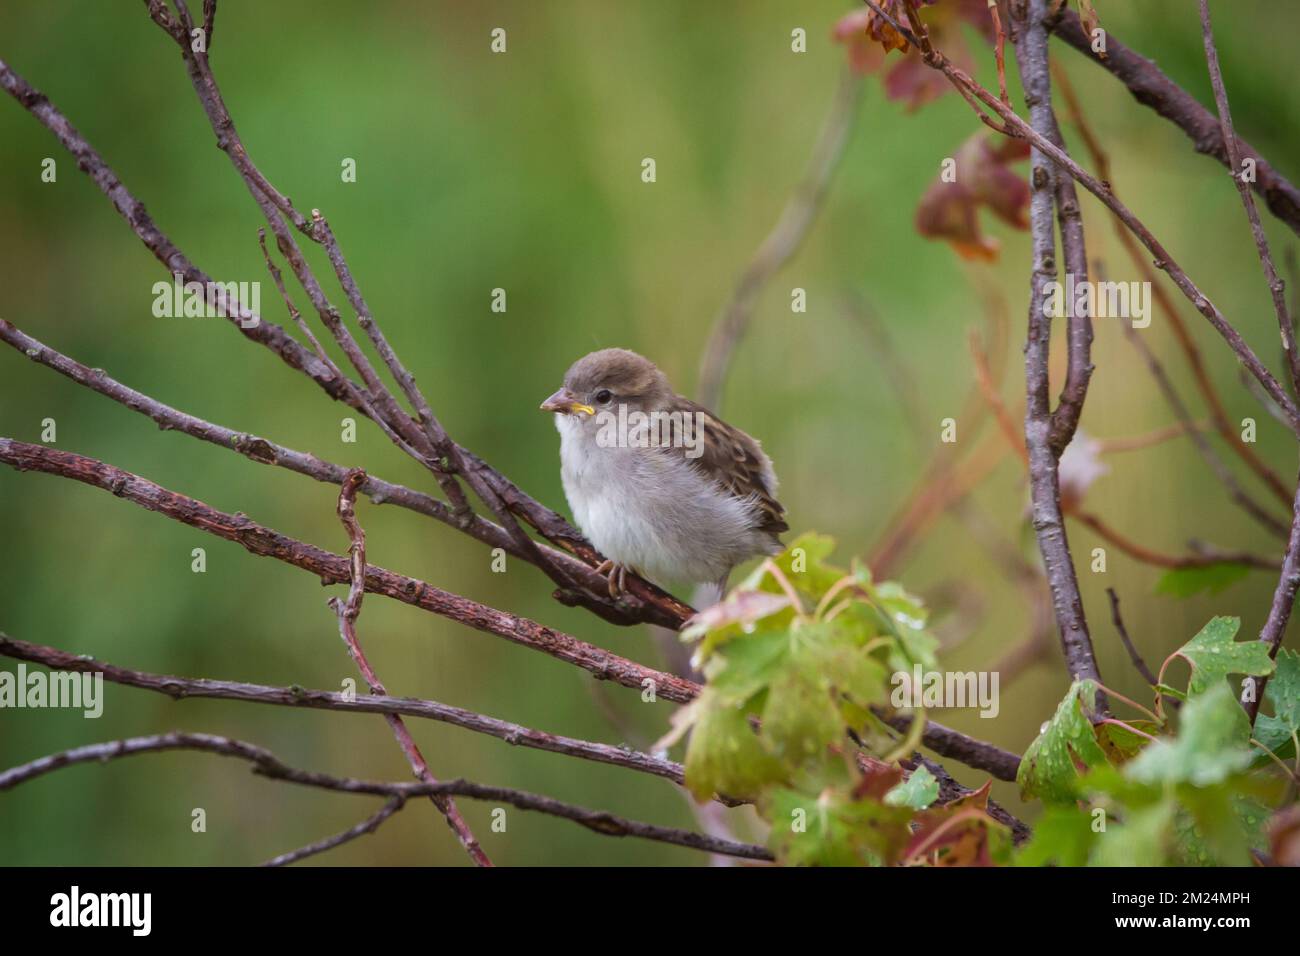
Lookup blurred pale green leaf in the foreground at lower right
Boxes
[1125,682,1253,787]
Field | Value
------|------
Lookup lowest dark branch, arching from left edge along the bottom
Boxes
[0,732,774,860]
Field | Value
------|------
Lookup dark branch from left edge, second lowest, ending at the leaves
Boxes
[0,633,691,803]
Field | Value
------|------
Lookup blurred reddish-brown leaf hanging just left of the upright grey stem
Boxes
[917,130,1030,261]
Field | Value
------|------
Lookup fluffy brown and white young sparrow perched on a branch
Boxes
[541,349,789,597]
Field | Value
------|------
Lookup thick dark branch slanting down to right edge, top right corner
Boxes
[1048,10,1300,234]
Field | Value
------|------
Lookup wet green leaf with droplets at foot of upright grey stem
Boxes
[1015,680,1106,803]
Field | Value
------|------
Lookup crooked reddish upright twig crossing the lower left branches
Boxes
[329,468,491,866]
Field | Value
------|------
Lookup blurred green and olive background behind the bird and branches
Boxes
[0,0,1300,865]
